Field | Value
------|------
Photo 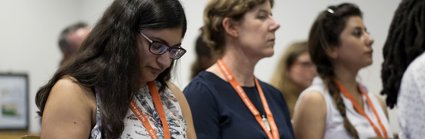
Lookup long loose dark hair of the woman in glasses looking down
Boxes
[36,0,186,138]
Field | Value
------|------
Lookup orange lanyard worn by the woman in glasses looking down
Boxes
[130,82,170,139]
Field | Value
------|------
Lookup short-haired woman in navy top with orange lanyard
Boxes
[183,0,294,139]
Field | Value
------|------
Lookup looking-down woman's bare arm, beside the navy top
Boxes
[167,82,196,139]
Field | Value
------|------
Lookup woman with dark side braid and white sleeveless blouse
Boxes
[292,3,393,139]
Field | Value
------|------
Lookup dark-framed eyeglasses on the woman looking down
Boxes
[140,32,186,60]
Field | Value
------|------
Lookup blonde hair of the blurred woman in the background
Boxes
[271,41,308,117]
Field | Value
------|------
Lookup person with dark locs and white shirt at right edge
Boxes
[381,0,425,139]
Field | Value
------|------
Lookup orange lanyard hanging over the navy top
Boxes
[217,59,279,139]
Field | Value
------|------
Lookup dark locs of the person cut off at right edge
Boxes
[381,0,425,108]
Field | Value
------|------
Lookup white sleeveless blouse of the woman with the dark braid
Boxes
[295,77,393,139]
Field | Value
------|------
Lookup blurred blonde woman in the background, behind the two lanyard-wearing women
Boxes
[271,41,316,116]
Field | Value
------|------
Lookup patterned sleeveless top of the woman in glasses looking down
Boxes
[91,83,187,139]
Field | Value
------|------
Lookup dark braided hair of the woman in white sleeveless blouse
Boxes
[308,3,362,138]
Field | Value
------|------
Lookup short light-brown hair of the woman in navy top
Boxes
[202,0,274,56]
